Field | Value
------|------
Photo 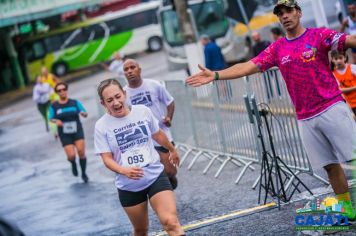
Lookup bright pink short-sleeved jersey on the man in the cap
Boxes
[252,28,346,120]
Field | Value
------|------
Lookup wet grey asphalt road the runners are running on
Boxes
[0,48,353,235]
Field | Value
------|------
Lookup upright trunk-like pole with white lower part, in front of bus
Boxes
[174,0,204,74]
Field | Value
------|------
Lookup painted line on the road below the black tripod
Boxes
[153,202,277,236]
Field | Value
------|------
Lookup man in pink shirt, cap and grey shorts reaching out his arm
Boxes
[186,0,356,221]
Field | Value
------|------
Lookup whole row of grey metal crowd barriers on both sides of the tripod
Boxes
[165,69,328,187]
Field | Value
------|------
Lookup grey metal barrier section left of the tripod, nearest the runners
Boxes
[165,80,259,183]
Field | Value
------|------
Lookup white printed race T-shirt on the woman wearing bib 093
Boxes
[94,105,163,192]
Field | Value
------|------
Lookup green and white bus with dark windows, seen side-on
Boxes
[18,1,162,80]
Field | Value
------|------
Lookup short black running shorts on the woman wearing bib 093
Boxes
[118,171,173,207]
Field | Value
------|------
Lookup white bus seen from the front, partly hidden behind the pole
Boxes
[159,0,249,70]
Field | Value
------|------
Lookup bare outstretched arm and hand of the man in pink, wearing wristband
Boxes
[186,61,260,87]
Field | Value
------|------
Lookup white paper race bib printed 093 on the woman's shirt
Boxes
[121,147,152,167]
